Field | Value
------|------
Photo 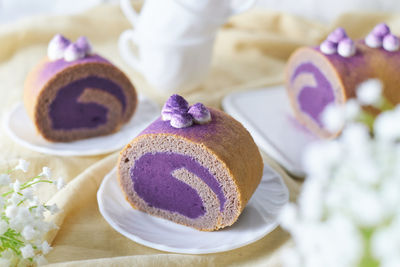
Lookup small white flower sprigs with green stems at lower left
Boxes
[0,160,65,266]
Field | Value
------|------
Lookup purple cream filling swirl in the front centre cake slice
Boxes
[130,152,226,219]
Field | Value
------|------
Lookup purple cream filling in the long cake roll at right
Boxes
[291,63,335,126]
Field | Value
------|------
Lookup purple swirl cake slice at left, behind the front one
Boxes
[24,34,137,142]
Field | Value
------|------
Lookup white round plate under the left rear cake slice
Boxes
[3,96,160,156]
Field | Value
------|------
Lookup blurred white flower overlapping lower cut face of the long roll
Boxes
[321,104,345,133]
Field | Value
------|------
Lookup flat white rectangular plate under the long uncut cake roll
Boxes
[222,85,318,177]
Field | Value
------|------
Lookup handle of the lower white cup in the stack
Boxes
[118,30,142,72]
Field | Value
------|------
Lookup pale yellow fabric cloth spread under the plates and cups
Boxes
[0,5,400,266]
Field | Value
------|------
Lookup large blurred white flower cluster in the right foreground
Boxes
[280,79,400,267]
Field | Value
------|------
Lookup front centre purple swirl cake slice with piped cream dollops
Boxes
[117,95,263,231]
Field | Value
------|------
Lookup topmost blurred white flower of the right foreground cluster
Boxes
[357,79,382,105]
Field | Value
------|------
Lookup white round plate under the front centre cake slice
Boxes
[97,166,289,254]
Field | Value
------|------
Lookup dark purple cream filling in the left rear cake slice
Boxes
[49,76,126,130]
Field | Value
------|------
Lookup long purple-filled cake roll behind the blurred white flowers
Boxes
[285,23,400,138]
